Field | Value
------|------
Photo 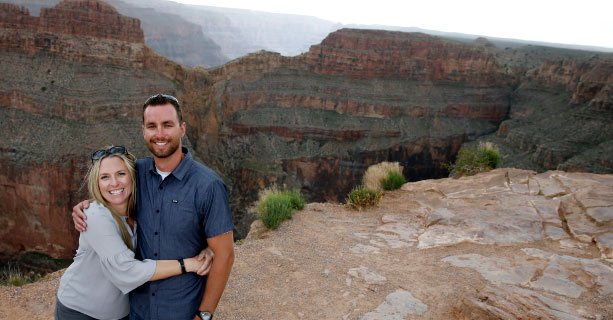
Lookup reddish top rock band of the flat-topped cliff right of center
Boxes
[307,29,506,86]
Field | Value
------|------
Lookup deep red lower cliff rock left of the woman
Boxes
[0,158,85,258]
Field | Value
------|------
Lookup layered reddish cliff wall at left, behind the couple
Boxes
[0,1,208,257]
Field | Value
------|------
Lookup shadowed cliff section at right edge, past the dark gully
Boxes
[490,47,613,172]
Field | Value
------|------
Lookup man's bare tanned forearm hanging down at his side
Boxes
[194,231,234,319]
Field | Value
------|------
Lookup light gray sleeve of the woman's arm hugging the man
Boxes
[82,208,156,294]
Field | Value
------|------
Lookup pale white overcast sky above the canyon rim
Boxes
[173,0,613,48]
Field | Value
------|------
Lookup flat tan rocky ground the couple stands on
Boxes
[0,169,613,319]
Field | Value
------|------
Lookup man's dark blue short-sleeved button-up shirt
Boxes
[130,148,234,319]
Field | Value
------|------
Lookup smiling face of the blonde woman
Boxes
[98,156,133,214]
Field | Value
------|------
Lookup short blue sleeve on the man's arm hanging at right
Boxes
[203,180,234,239]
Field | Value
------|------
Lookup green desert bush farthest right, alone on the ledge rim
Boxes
[447,142,502,177]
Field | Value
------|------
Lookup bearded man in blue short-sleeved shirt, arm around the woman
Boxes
[73,94,234,320]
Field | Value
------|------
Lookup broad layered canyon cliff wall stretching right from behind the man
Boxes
[189,29,613,235]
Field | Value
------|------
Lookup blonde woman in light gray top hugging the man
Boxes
[55,146,211,320]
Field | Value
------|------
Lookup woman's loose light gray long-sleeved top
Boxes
[57,202,156,319]
